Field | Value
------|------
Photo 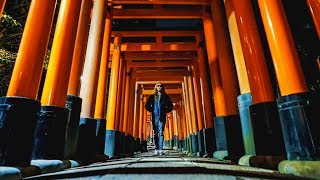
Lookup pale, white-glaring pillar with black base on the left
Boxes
[78,0,110,160]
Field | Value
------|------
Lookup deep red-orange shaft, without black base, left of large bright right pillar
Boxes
[232,0,274,104]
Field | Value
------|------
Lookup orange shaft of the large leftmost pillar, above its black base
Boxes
[7,0,56,99]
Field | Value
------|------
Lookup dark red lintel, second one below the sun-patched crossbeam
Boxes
[127,61,192,67]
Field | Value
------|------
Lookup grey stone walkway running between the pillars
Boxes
[26,146,306,180]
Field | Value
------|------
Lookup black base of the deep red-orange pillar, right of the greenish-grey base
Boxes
[249,102,285,156]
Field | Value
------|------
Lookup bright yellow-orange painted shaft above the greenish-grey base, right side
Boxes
[224,0,250,94]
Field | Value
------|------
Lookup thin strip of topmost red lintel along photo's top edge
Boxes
[109,0,210,5]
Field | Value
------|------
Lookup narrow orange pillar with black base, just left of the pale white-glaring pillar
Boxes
[65,0,92,158]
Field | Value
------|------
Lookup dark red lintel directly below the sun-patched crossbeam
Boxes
[124,51,197,61]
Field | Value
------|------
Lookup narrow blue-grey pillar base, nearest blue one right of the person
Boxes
[213,116,227,151]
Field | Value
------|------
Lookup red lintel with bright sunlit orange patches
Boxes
[110,43,198,54]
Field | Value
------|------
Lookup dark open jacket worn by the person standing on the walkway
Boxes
[145,93,173,121]
